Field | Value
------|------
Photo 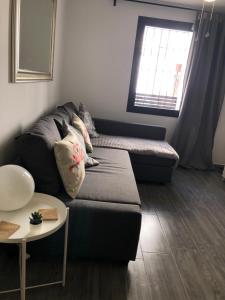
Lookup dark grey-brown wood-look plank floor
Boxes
[0,168,225,300]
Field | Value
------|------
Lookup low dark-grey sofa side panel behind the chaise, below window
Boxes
[94,119,166,140]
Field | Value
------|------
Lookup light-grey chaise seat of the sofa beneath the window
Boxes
[92,134,179,161]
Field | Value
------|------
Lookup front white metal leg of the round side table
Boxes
[20,239,27,300]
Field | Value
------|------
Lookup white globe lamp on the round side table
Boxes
[0,165,35,211]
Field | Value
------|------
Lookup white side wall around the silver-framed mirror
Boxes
[0,0,65,165]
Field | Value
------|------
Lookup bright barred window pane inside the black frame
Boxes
[134,26,193,110]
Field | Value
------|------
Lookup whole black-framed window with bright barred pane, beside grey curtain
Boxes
[127,17,193,117]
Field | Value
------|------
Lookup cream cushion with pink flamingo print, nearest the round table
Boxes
[54,133,85,199]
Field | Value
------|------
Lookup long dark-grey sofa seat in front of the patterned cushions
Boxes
[58,148,140,205]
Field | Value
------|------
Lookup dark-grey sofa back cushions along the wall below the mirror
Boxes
[16,103,76,195]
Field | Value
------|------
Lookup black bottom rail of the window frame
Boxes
[127,106,179,118]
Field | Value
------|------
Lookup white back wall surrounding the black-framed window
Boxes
[60,0,195,139]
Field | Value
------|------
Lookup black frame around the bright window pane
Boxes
[127,16,193,117]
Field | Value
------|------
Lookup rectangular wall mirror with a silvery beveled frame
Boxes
[11,0,57,82]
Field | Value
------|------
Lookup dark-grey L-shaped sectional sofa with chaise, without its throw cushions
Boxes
[16,103,178,262]
